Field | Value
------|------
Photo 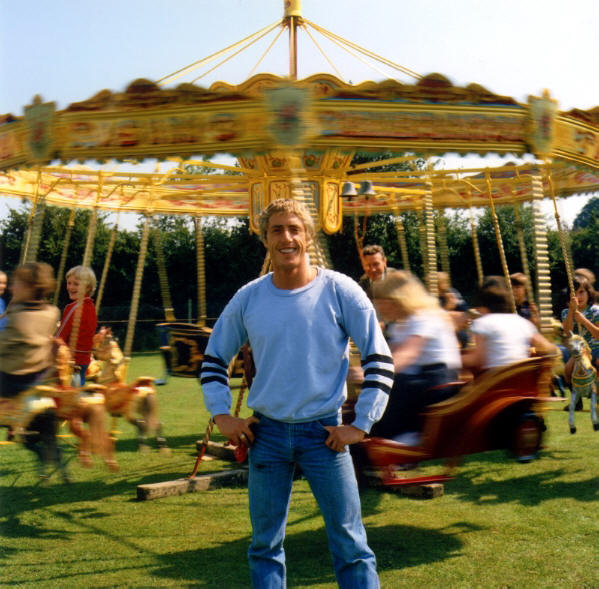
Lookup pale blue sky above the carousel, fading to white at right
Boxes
[0,0,599,227]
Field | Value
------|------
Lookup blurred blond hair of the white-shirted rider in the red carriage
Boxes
[372,270,442,315]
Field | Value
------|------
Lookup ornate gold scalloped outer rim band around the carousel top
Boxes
[0,74,599,169]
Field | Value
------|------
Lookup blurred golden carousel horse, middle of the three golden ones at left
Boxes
[46,339,119,471]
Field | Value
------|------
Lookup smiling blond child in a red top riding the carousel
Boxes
[56,266,98,386]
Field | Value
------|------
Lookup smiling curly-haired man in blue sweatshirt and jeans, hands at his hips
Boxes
[201,199,393,589]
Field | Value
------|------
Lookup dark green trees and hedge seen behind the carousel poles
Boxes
[0,193,599,350]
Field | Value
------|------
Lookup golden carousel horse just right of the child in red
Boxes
[87,327,168,452]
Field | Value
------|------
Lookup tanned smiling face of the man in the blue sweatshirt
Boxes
[266,212,310,270]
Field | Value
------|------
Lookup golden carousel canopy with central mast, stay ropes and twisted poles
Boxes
[0,0,599,486]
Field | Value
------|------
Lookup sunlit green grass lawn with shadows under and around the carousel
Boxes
[0,356,599,589]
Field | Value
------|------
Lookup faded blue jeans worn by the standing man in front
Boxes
[248,414,379,589]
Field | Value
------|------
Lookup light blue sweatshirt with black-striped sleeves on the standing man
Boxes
[200,268,393,432]
